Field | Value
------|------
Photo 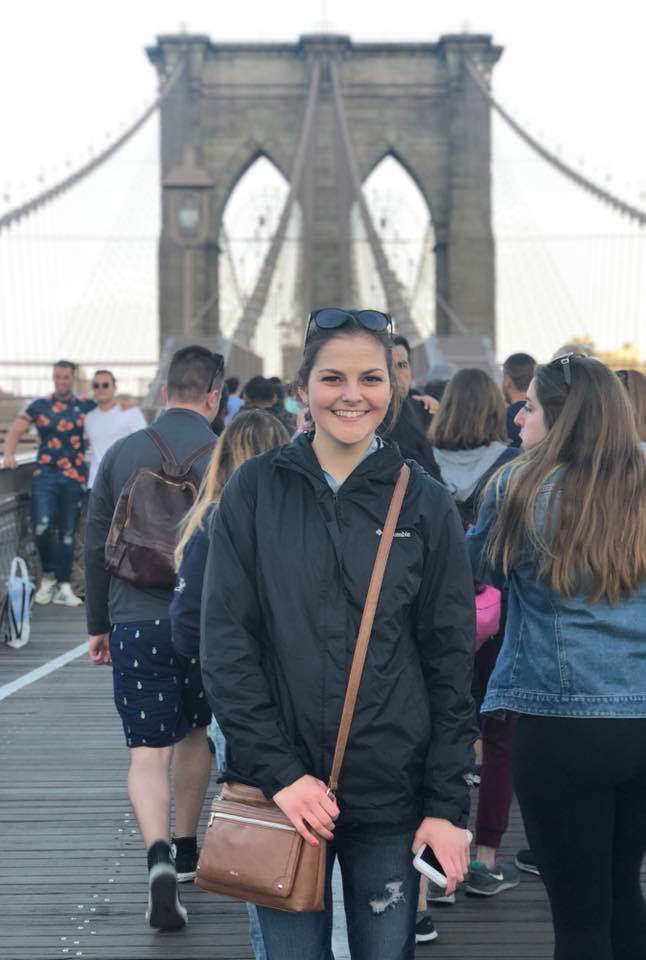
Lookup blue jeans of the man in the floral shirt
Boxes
[31,467,83,583]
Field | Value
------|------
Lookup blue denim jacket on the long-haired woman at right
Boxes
[467,472,646,717]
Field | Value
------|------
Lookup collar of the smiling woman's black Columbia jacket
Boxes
[274,432,404,496]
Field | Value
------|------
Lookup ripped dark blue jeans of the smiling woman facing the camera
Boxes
[258,827,419,960]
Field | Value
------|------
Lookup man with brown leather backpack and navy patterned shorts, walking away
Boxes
[85,346,224,930]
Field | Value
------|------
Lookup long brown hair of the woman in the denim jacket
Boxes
[487,356,646,603]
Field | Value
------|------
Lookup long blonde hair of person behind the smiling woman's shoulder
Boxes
[175,409,289,569]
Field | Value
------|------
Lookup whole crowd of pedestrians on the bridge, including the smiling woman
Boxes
[5,320,646,960]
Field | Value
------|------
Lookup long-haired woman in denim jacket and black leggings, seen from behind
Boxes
[467,354,646,960]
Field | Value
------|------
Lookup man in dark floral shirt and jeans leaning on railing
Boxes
[4,360,96,607]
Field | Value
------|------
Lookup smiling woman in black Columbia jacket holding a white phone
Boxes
[201,308,476,960]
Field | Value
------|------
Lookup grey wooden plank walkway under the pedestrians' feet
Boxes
[0,606,628,960]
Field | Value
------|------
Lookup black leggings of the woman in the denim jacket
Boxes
[513,716,646,960]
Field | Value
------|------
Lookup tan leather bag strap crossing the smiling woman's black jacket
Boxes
[328,464,410,795]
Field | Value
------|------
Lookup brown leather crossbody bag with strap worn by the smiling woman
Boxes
[195,464,410,912]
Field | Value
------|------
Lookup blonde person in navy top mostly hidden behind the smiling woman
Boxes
[170,409,289,960]
